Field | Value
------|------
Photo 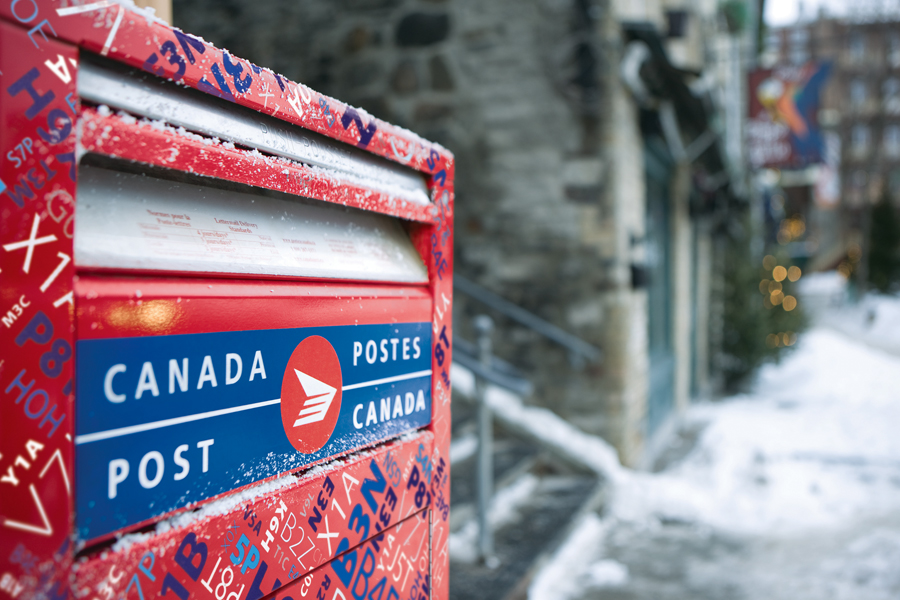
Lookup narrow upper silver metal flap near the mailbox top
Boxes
[78,55,430,205]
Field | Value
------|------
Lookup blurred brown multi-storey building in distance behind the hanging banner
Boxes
[760,13,900,290]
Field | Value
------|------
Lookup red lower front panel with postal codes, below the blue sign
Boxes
[75,432,433,600]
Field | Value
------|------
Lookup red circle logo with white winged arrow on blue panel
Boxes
[281,335,342,454]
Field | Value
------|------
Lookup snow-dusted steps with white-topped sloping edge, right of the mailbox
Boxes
[450,364,620,600]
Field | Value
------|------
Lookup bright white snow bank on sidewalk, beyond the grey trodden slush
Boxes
[613,329,900,533]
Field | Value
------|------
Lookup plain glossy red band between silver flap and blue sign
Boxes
[75,274,432,339]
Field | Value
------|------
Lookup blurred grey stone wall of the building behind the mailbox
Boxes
[174,0,647,464]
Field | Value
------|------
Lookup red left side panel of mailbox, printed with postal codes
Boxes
[0,17,78,597]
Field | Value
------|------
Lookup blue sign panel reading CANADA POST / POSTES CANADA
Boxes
[75,323,431,540]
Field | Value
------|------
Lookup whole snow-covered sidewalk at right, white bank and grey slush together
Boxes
[529,328,900,600]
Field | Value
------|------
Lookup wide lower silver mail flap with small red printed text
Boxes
[75,165,428,283]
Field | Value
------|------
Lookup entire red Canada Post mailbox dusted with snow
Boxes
[0,5,454,600]
